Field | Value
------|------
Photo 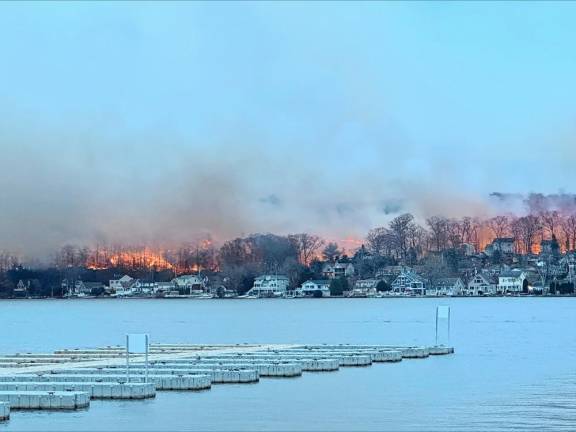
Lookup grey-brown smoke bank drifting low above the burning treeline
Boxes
[0,120,574,259]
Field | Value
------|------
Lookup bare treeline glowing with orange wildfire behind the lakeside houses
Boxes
[0,206,576,295]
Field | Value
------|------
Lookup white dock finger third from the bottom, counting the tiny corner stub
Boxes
[0,382,156,399]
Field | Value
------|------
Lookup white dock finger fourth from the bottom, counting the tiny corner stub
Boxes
[0,372,212,390]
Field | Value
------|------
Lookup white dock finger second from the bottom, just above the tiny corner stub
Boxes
[0,391,90,410]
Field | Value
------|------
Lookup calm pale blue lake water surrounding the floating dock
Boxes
[0,298,576,432]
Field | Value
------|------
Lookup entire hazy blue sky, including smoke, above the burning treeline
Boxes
[0,2,576,251]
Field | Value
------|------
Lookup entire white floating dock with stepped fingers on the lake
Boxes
[0,344,454,421]
